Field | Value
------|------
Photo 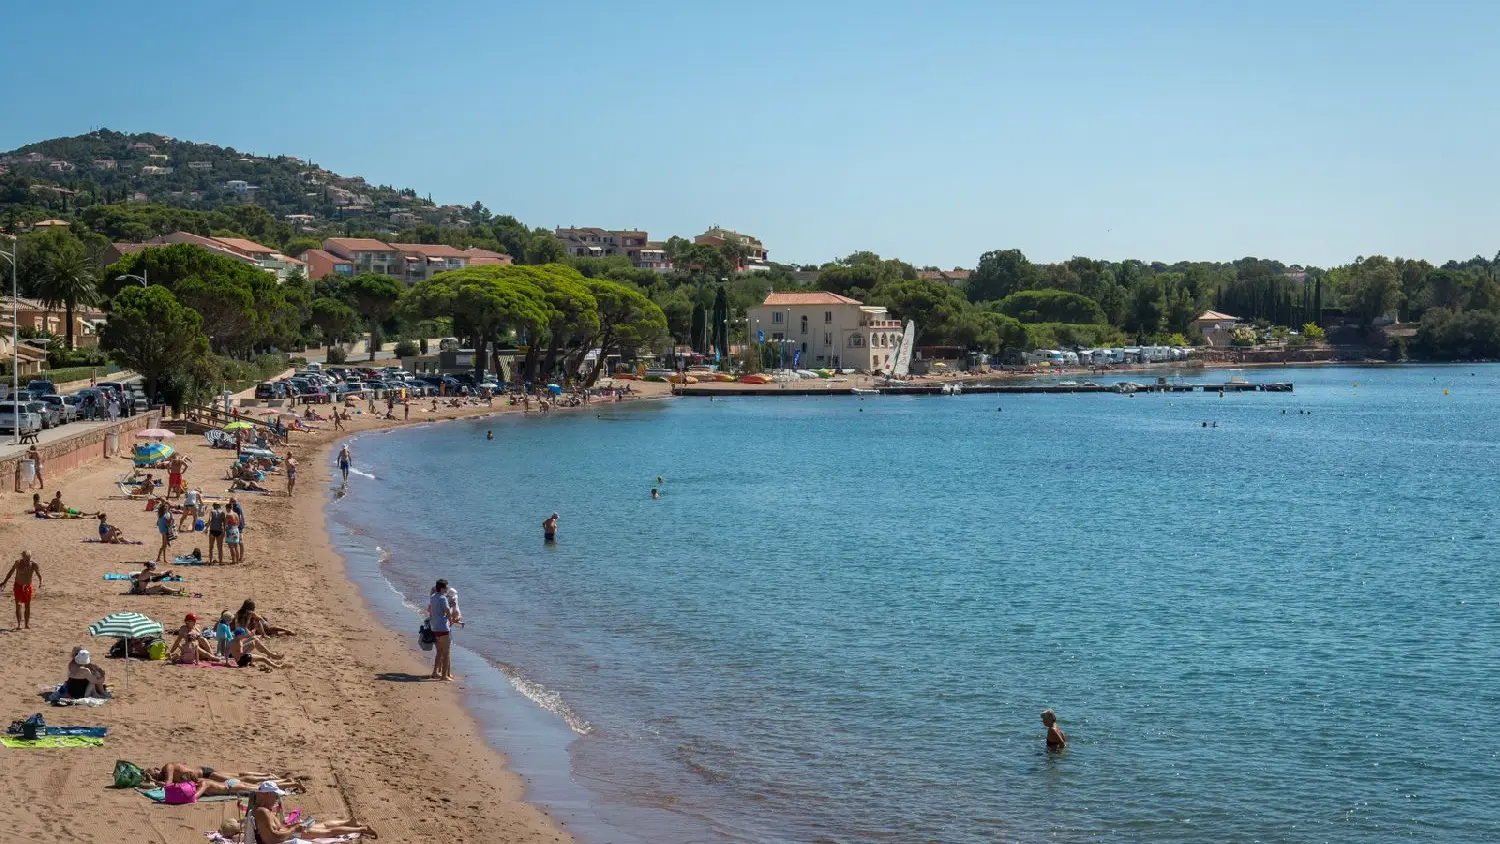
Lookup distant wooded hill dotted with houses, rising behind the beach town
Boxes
[0,129,488,232]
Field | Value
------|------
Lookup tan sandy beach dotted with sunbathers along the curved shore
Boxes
[0,384,666,844]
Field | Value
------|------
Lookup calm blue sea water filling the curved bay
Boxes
[325,366,1500,843]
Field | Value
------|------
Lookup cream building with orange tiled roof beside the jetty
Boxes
[746,292,902,372]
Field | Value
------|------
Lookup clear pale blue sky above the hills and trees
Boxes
[0,0,1500,267]
